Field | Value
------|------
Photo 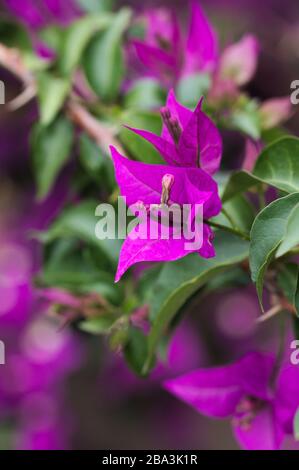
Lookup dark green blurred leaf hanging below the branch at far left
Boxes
[32,117,73,200]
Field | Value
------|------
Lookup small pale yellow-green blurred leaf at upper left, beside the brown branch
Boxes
[37,72,71,126]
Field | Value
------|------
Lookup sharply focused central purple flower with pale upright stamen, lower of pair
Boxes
[111,147,221,281]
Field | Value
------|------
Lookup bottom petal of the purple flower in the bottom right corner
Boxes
[234,405,284,450]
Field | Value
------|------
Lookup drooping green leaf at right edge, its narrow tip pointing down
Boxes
[249,193,299,308]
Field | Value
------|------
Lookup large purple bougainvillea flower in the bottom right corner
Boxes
[164,352,299,450]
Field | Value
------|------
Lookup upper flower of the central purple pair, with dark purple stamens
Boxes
[131,90,222,174]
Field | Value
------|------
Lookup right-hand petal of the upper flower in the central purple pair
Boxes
[178,100,222,174]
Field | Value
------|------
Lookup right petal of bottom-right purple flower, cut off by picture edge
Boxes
[275,364,299,434]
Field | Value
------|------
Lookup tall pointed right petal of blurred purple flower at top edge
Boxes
[183,0,218,75]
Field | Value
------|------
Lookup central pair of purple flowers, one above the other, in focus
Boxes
[111,91,222,281]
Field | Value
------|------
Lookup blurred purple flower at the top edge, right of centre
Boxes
[134,0,218,84]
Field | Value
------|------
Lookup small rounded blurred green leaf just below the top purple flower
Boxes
[124,78,166,110]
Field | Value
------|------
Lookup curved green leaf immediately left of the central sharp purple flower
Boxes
[39,200,121,267]
